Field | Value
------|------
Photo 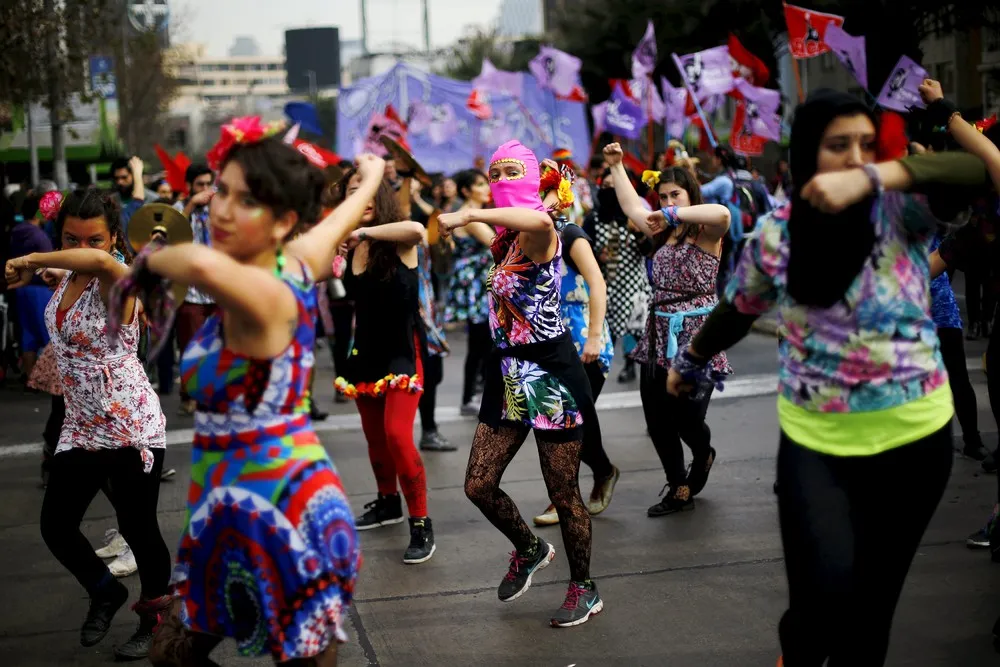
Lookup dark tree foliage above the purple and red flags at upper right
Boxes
[552,0,1000,100]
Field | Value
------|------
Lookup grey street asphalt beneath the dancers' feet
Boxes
[0,326,1000,667]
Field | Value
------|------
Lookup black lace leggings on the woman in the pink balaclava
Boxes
[465,424,590,581]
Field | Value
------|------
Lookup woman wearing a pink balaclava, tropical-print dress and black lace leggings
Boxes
[439,141,604,627]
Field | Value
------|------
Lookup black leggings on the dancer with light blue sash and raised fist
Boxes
[639,364,712,489]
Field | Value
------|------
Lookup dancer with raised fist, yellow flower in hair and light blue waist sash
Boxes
[604,144,732,517]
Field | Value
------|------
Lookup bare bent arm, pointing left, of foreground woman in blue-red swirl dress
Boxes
[149,243,296,329]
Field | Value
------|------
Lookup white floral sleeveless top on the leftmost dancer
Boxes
[45,274,167,472]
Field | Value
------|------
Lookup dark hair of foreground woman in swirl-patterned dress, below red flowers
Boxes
[222,137,325,239]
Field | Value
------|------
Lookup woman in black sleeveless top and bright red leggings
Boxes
[336,171,437,564]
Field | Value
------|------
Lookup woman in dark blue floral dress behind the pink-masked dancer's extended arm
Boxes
[444,169,493,416]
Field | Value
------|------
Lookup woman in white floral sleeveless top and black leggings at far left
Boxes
[6,190,170,660]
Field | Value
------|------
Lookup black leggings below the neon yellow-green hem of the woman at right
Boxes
[778,424,952,667]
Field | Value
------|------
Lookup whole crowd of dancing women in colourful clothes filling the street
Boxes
[3,75,1000,667]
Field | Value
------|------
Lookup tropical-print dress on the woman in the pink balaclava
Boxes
[488,232,583,430]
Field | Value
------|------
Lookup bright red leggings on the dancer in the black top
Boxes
[355,389,427,518]
